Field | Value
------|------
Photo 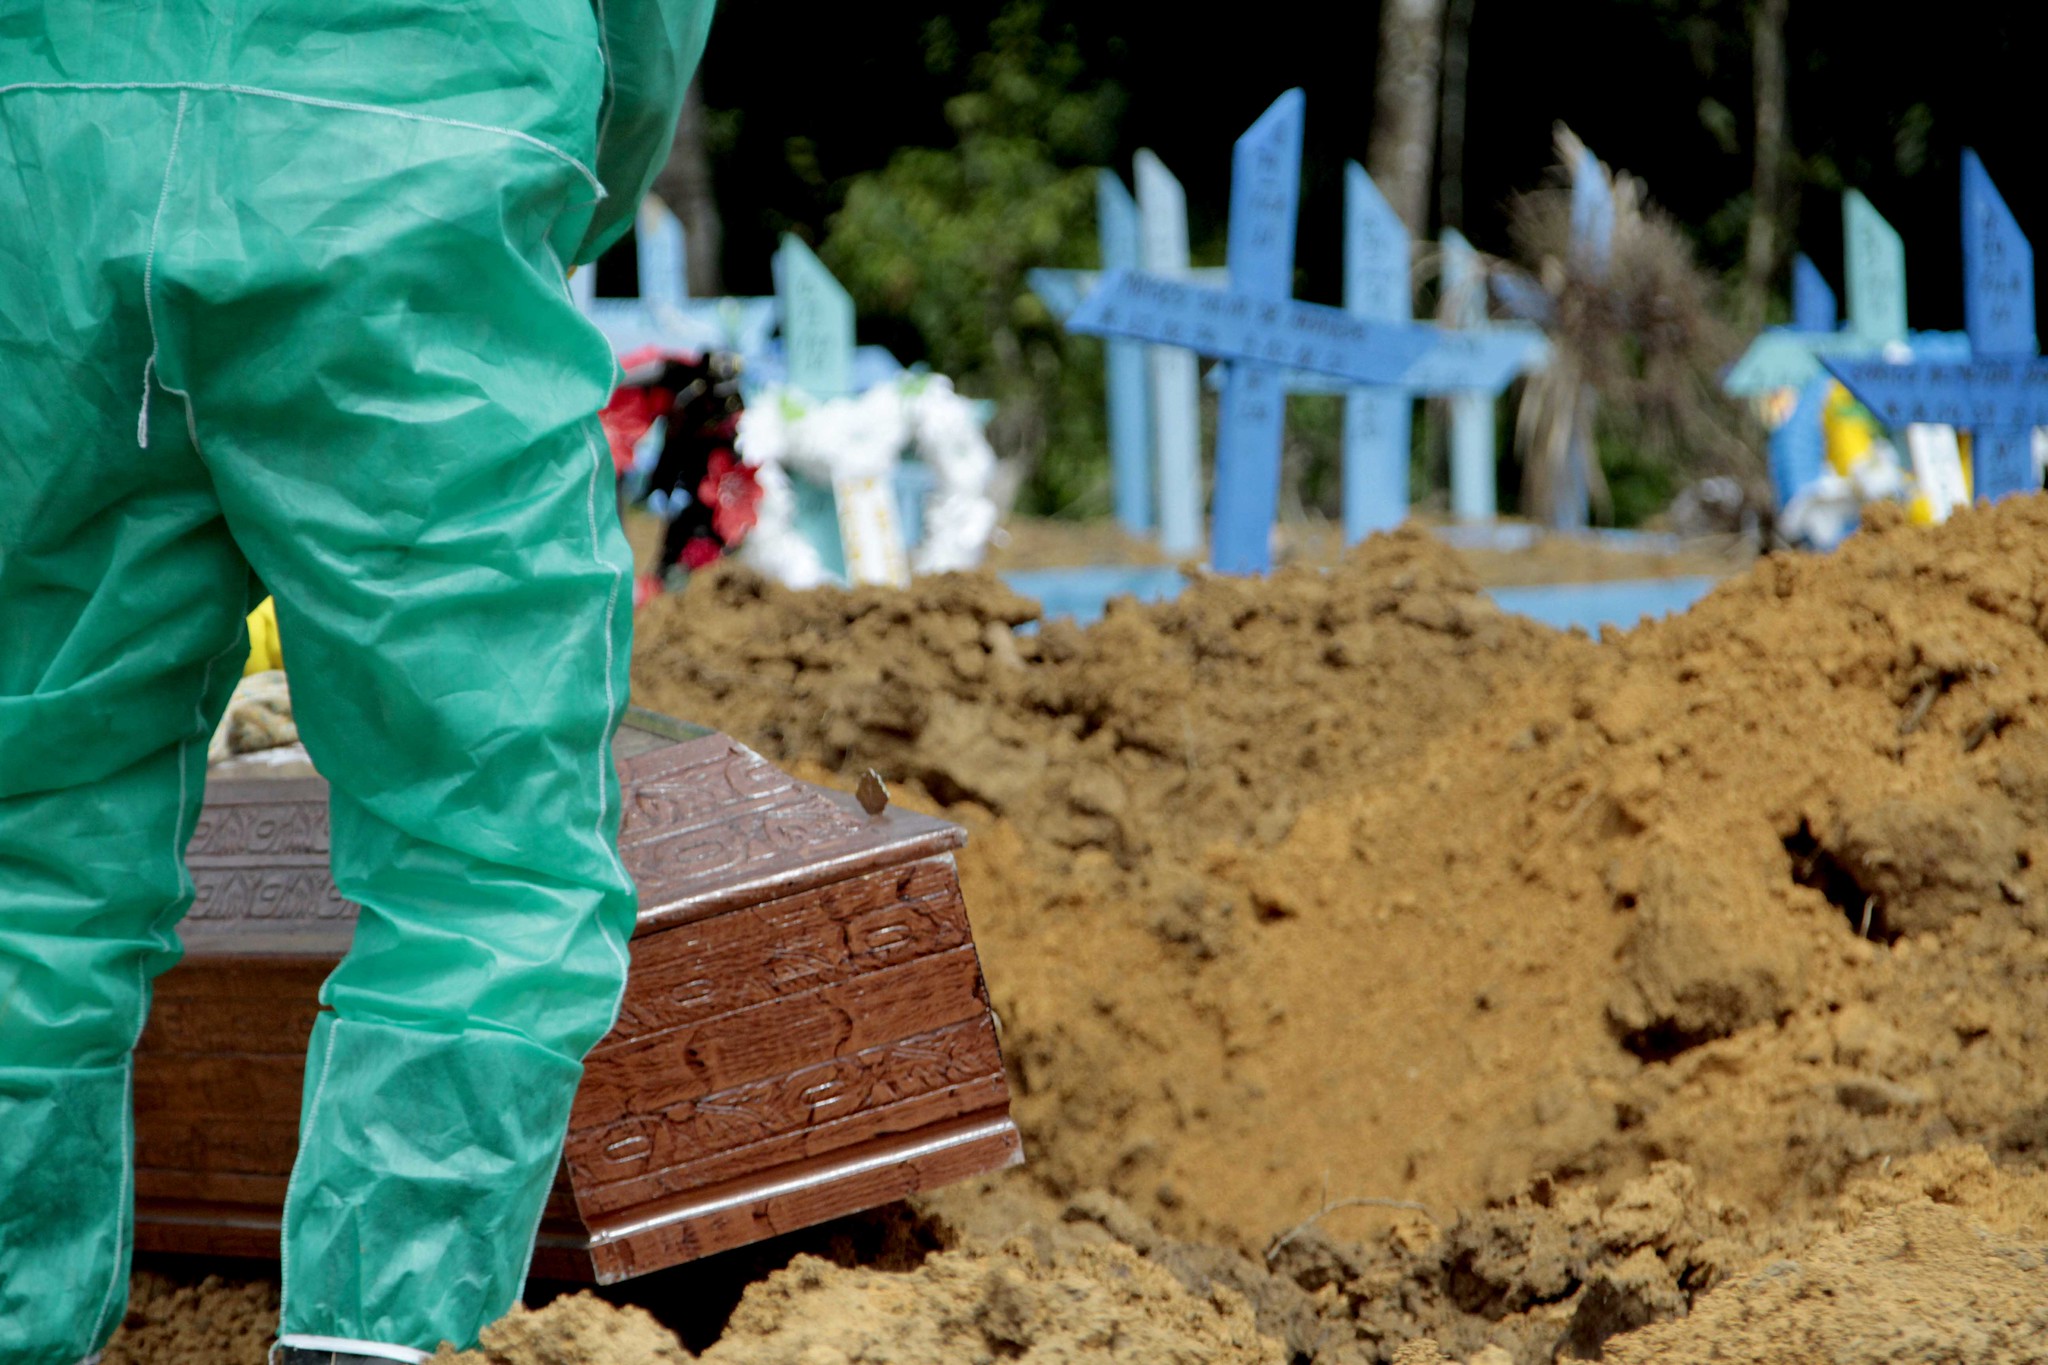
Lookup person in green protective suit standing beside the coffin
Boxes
[0,0,711,1365]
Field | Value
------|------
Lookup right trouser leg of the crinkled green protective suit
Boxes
[156,98,633,1351]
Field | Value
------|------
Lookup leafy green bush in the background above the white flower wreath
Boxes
[819,0,1122,514]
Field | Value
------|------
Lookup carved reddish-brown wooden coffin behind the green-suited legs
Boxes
[135,712,1022,1283]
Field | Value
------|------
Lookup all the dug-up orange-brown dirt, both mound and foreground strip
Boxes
[123,499,2048,1365]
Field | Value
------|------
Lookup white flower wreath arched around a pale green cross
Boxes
[735,372,995,587]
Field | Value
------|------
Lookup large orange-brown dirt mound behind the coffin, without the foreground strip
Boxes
[635,499,2048,1248]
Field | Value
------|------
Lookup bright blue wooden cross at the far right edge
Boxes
[1823,151,2048,501]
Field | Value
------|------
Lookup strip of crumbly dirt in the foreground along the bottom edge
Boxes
[407,1146,2048,1365]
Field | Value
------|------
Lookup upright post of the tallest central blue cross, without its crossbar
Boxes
[1210,90,1303,573]
